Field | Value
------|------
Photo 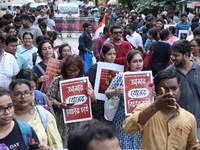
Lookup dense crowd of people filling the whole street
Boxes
[0,1,200,150]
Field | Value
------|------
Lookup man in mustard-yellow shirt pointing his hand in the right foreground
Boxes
[123,70,199,150]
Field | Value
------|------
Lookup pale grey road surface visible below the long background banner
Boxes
[55,34,96,63]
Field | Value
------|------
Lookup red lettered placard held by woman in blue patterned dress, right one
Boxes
[123,71,153,116]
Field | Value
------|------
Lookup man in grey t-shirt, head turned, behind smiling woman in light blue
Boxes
[17,14,42,46]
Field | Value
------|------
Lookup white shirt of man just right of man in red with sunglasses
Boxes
[126,32,143,48]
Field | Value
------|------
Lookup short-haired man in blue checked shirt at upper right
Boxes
[176,13,191,36]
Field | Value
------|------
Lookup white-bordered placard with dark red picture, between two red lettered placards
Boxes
[94,62,124,101]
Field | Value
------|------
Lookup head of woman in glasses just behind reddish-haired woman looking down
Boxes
[58,43,72,61]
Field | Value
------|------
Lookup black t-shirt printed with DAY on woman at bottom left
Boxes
[0,120,39,150]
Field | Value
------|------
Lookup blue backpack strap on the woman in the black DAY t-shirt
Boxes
[16,120,32,149]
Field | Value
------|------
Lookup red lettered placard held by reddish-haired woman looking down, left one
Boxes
[60,77,92,123]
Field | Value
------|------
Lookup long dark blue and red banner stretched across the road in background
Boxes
[54,17,98,33]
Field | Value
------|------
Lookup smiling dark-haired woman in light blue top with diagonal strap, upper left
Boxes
[16,32,37,62]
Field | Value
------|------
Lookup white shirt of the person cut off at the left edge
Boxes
[0,51,19,89]
